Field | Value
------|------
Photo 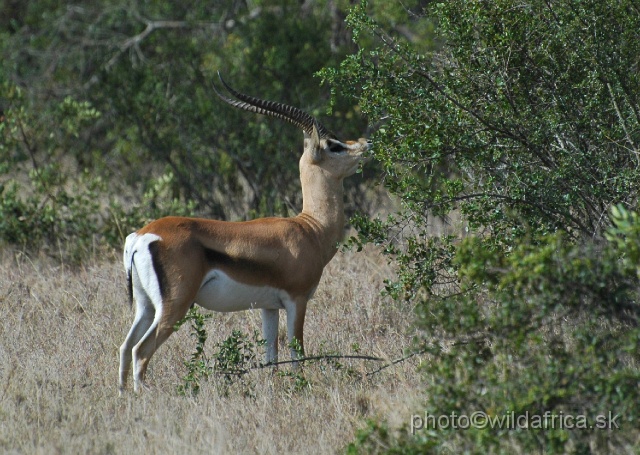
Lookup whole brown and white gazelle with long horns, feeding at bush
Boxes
[119,77,369,392]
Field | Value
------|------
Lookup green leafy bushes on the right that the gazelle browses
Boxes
[322,0,640,453]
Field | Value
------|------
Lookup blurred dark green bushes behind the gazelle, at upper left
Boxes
[0,0,378,254]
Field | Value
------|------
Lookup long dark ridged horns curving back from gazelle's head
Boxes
[211,71,335,139]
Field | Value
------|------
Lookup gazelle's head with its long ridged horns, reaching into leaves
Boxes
[213,73,371,180]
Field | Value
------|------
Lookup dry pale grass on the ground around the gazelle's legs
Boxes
[0,251,421,454]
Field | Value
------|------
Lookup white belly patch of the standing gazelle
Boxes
[195,269,289,312]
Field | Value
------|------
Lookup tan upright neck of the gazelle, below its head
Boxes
[300,166,344,262]
